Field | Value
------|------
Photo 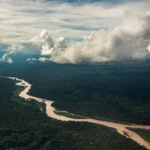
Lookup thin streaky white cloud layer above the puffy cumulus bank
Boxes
[0,0,149,44]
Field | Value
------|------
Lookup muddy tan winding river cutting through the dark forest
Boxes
[7,77,150,150]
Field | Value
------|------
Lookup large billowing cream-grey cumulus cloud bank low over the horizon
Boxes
[32,12,150,64]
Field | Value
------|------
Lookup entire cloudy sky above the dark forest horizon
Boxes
[0,0,150,64]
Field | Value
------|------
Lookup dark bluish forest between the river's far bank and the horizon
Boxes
[0,62,150,124]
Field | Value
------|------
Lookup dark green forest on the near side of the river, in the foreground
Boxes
[0,78,145,150]
